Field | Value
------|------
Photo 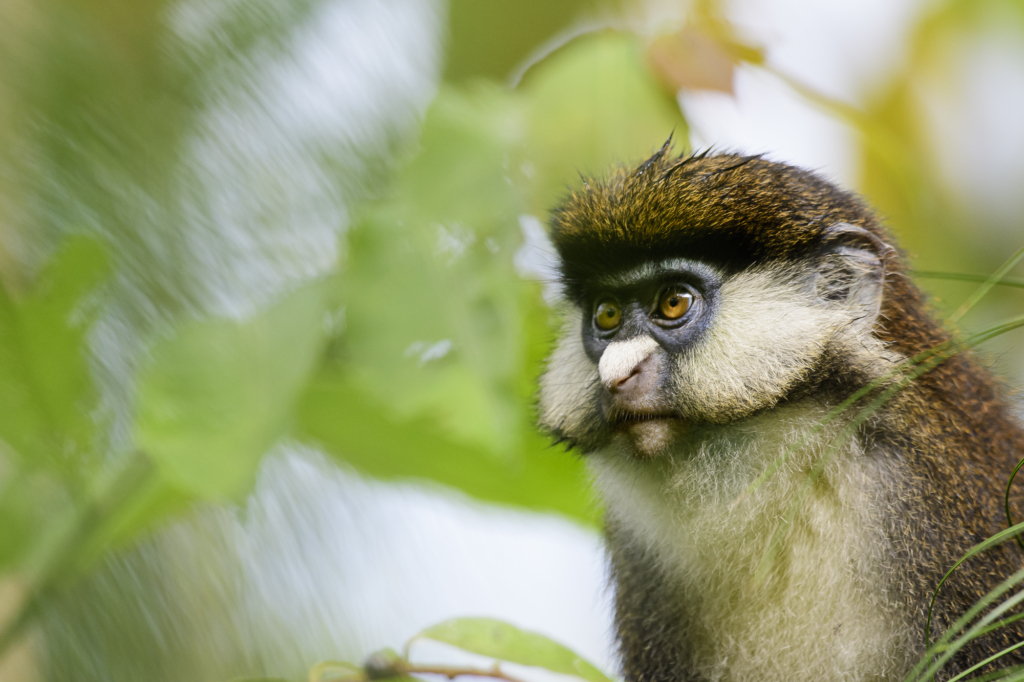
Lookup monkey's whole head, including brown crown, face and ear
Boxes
[540,143,893,458]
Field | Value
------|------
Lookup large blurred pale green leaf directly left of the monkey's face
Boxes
[342,88,532,457]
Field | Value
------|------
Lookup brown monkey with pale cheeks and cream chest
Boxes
[538,138,1024,682]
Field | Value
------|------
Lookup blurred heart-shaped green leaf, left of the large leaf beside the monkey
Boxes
[135,283,326,498]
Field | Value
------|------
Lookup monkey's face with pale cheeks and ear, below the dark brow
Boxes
[541,236,891,459]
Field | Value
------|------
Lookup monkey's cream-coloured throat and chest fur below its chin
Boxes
[590,400,912,681]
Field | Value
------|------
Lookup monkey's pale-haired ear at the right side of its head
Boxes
[816,222,896,329]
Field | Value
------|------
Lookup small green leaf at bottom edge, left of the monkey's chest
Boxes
[414,619,611,682]
